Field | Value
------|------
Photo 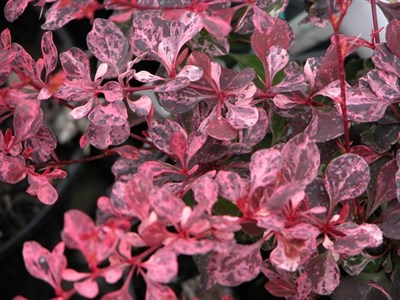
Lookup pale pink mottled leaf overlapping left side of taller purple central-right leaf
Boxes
[249,149,283,190]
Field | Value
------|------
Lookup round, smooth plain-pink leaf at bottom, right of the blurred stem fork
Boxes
[143,248,178,283]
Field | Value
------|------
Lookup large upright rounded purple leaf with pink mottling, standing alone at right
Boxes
[325,153,370,208]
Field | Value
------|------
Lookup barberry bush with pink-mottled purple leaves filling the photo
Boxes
[0,0,400,300]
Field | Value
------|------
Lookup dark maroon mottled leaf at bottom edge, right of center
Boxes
[304,251,340,295]
